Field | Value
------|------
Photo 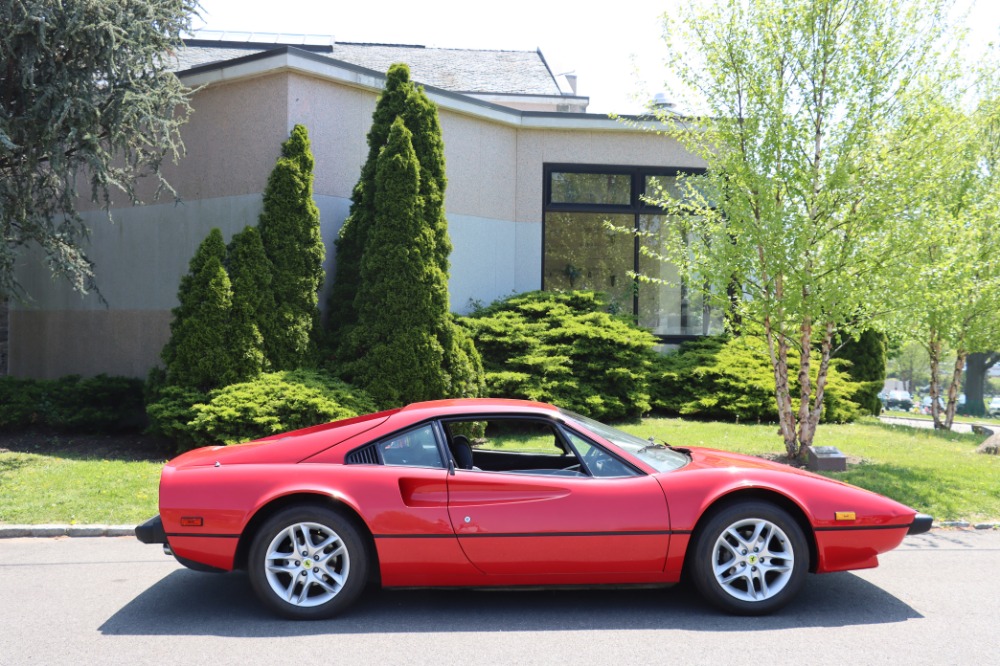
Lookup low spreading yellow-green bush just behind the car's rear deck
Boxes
[147,370,375,451]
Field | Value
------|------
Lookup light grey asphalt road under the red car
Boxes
[0,530,1000,666]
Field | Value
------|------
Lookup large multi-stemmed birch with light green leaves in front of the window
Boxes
[644,0,947,457]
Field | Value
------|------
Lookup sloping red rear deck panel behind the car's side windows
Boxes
[168,414,388,468]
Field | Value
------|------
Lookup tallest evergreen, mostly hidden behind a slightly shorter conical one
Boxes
[327,63,451,338]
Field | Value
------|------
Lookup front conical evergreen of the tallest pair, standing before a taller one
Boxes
[347,118,449,407]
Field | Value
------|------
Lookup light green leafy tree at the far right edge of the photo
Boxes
[897,85,1000,430]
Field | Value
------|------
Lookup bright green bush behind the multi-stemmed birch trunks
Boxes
[652,335,862,423]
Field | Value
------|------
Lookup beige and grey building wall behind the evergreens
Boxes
[9,70,699,378]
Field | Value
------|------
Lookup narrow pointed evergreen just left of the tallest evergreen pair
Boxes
[259,125,325,370]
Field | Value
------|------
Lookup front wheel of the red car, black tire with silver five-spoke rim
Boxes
[689,500,809,615]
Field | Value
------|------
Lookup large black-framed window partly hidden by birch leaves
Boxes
[542,165,722,342]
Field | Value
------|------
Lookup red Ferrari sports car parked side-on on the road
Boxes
[136,399,931,619]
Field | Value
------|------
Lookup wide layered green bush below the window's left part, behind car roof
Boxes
[462,291,657,419]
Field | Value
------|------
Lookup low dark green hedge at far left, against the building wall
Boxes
[0,375,145,433]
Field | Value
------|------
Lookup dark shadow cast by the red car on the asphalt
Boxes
[100,570,922,637]
